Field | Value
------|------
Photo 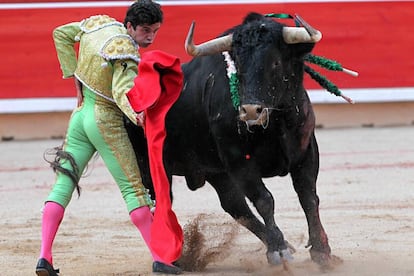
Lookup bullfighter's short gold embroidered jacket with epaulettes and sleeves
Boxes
[53,15,139,123]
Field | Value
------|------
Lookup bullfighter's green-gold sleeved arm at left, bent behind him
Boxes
[53,22,81,78]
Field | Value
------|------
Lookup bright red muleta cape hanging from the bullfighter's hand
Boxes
[127,50,183,263]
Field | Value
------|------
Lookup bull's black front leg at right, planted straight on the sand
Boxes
[291,137,331,266]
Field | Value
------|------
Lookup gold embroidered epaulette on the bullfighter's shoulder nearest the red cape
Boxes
[100,34,140,62]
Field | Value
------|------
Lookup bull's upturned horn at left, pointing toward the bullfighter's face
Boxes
[184,21,233,56]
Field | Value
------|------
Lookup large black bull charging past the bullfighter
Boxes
[127,14,331,265]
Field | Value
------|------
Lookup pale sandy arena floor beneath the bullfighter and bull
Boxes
[0,127,414,276]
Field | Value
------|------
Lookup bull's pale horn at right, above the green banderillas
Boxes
[283,15,322,44]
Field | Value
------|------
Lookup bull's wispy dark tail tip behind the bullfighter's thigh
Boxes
[43,146,81,196]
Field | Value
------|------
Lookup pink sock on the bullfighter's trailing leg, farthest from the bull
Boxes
[40,201,65,265]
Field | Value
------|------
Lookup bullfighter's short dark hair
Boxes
[124,0,164,29]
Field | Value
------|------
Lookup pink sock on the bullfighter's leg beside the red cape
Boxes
[129,206,160,261]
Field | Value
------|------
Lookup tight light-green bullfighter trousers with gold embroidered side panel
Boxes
[47,87,153,212]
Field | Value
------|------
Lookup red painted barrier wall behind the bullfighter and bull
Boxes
[0,1,414,99]
